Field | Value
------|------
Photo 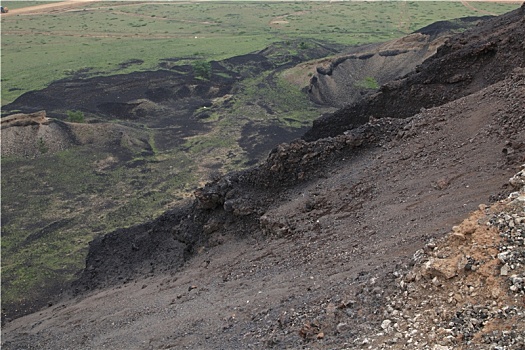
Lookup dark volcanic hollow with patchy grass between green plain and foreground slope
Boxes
[1,18,492,320]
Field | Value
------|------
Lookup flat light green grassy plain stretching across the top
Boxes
[1,1,519,105]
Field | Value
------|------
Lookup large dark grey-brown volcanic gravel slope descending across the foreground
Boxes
[2,7,525,349]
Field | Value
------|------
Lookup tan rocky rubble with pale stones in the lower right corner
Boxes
[362,165,525,350]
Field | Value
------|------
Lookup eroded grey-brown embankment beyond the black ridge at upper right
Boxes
[308,17,486,107]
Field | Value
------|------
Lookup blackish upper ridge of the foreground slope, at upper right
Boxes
[304,6,525,140]
